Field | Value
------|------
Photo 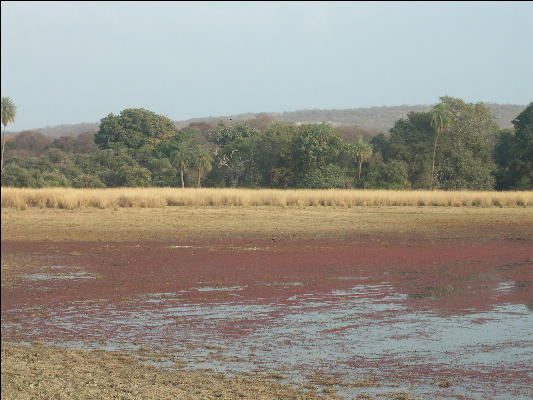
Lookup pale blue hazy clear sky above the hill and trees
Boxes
[1,1,533,131]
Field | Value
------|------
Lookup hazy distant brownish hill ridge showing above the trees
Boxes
[7,103,526,137]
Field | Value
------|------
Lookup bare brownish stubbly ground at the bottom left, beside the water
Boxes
[2,342,328,400]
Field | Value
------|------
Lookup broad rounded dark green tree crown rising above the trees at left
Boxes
[94,108,176,150]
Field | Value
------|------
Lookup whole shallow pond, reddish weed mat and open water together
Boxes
[2,236,533,399]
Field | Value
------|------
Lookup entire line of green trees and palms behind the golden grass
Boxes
[2,97,533,190]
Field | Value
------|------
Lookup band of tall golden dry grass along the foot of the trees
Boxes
[1,188,533,209]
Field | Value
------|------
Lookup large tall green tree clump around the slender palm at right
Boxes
[389,97,497,189]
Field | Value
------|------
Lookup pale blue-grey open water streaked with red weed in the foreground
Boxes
[2,282,533,399]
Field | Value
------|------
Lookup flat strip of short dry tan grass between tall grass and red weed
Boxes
[2,206,533,241]
